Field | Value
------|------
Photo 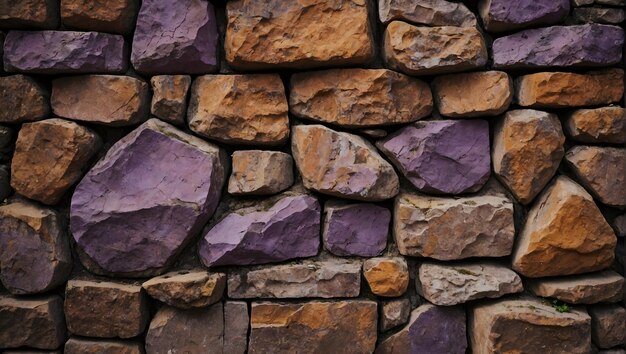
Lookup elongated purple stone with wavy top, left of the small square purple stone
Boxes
[199,195,320,267]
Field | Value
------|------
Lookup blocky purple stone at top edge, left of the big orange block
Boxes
[131,0,218,75]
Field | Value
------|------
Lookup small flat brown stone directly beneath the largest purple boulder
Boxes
[141,270,226,309]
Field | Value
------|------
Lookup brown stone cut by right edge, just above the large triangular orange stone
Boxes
[565,146,626,207]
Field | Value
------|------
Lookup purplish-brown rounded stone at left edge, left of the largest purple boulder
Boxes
[0,201,72,294]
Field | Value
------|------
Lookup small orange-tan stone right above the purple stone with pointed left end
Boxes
[433,71,513,118]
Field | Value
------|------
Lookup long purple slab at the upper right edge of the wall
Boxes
[493,24,624,69]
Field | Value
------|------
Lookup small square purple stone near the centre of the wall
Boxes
[323,201,391,257]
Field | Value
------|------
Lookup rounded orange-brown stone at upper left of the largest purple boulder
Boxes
[11,118,101,204]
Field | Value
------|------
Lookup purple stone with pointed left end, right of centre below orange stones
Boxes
[377,120,491,194]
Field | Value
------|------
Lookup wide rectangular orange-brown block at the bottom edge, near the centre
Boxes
[248,300,377,354]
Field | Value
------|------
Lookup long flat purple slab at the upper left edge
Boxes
[4,31,128,74]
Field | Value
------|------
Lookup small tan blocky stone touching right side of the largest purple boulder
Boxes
[228,150,293,195]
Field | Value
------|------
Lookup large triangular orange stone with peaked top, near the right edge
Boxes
[513,176,617,278]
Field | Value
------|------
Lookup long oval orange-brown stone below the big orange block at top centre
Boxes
[289,69,433,128]
